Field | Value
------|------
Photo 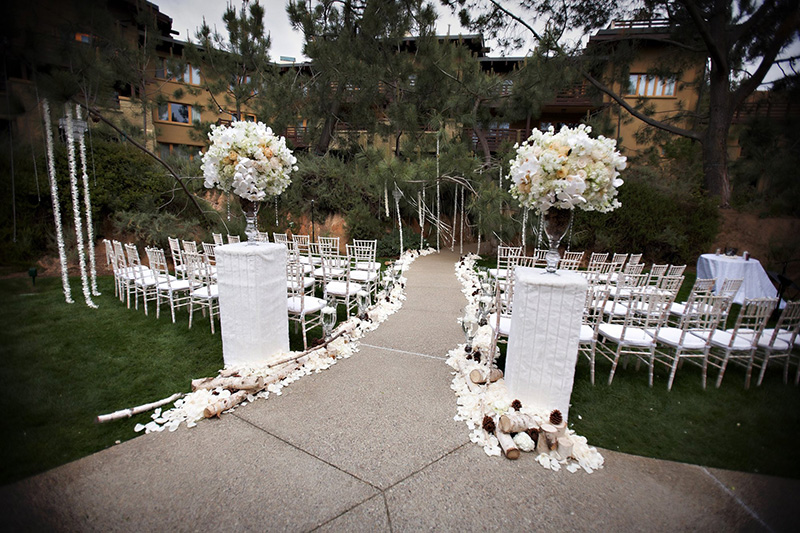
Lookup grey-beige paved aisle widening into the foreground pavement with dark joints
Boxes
[0,253,800,532]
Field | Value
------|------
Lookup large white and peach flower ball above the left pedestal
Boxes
[200,121,297,202]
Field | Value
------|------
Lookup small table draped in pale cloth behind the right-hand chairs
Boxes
[697,254,778,304]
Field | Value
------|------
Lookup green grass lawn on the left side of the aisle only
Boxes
[0,277,328,484]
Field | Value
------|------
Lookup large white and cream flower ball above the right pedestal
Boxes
[509,124,626,213]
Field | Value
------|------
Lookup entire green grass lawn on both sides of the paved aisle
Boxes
[0,264,800,484]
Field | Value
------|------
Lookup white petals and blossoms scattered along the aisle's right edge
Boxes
[454,254,604,474]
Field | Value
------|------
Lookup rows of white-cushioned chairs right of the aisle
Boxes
[487,246,800,390]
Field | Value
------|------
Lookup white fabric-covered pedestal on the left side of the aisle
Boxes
[215,242,289,366]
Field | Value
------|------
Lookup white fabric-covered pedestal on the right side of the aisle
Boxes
[505,267,587,420]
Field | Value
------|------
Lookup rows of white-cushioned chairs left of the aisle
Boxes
[104,232,399,349]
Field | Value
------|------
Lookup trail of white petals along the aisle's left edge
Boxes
[133,248,435,433]
